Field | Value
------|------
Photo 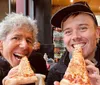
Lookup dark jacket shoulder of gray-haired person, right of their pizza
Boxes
[29,51,48,75]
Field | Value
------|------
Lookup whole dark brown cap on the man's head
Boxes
[51,1,98,28]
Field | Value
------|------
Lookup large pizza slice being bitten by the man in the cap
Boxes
[60,45,91,85]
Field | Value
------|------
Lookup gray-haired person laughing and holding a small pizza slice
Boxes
[0,13,44,85]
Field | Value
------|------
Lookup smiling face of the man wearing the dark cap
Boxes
[63,14,99,58]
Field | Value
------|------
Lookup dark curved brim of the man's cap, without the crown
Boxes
[51,4,93,28]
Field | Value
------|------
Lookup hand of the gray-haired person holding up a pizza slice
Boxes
[2,66,37,85]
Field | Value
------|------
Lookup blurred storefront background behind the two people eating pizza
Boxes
[0,0,100,61]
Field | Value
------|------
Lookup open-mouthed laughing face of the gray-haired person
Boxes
[0,26,33,67]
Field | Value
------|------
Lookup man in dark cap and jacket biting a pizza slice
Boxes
[47,1,100,85]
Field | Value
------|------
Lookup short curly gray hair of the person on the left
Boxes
[0,12,38,41]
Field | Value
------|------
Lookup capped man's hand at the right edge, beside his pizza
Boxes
[86,60,100,85]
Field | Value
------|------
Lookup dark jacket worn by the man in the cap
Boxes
[46,45,100,85]
